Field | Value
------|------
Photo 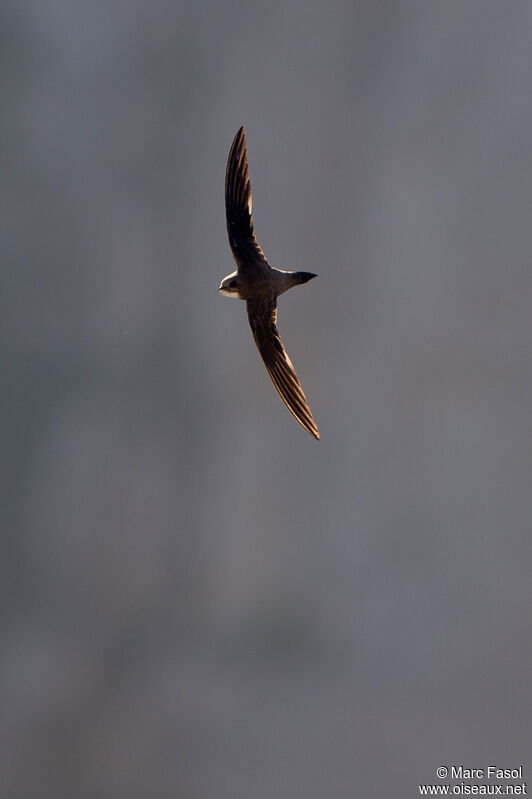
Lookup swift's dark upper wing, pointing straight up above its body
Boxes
[225,128,266,269]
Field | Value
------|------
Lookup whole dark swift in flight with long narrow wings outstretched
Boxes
[218,128,320,440]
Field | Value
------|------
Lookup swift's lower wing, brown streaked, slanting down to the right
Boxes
[246,296,320,440]
